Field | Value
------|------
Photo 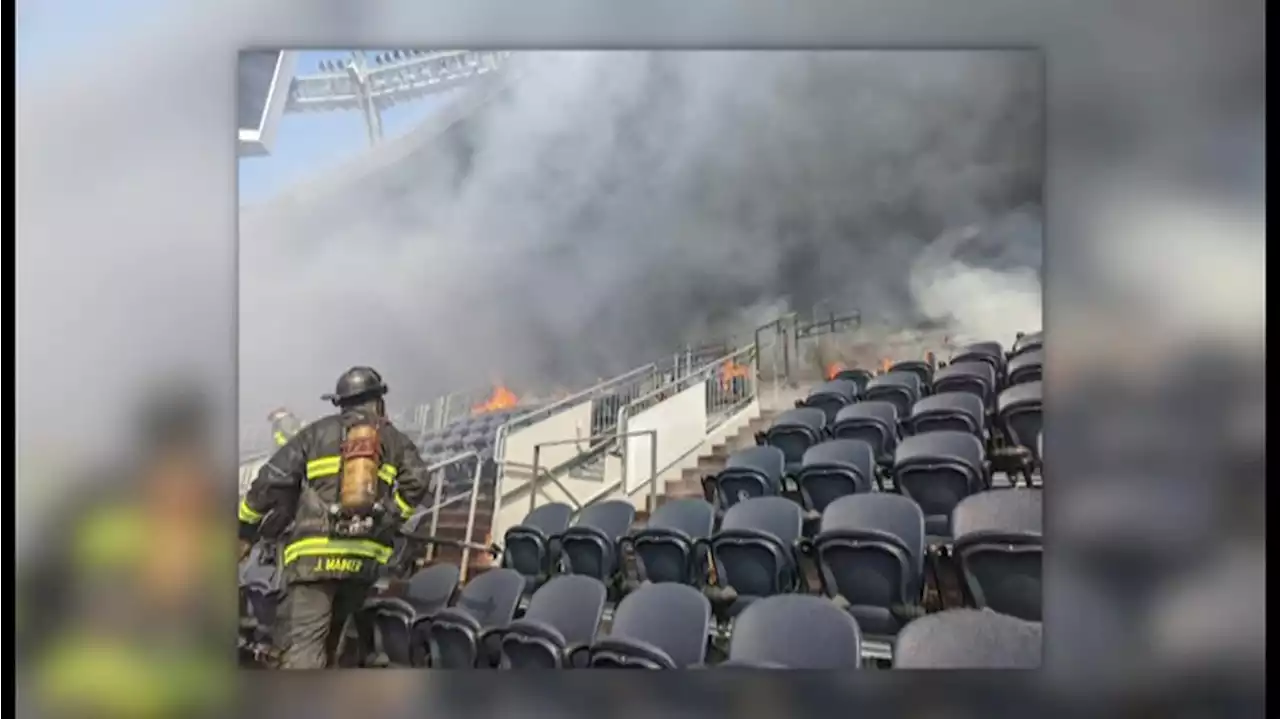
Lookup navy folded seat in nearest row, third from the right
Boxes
[589,583,712,669]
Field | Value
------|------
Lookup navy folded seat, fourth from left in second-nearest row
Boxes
[705,496,804,618]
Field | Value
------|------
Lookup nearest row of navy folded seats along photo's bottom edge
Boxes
[348,564,1041,669]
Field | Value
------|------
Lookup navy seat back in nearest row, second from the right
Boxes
[728,595,861,669]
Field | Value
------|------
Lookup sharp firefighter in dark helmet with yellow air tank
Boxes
[239,367,430,669]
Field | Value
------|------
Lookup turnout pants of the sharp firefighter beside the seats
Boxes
[275,580,371,669]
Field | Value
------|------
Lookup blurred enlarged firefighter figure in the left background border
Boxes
[17,386,236,719]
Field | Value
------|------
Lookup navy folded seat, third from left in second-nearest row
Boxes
[621,499,716,586]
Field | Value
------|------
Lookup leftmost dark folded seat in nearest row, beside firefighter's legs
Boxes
[356,564,458,667]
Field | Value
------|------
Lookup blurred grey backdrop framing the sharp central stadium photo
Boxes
[17,0,1266,718]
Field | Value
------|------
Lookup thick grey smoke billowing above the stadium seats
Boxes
[241,51,1043,418]
